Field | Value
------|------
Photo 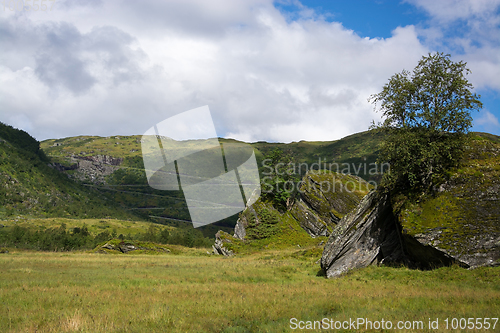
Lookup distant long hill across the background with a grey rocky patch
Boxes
[41,132,382,231]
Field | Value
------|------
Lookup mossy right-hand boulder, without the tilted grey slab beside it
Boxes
[399,138,500,267]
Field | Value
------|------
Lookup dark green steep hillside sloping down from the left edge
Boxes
[0,123,137,219]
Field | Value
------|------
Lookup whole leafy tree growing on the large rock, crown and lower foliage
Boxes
[369,53,482,192]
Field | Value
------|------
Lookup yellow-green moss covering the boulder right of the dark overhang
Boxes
[400,133,500,255]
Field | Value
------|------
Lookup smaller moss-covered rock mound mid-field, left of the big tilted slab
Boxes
[215,170,372,255]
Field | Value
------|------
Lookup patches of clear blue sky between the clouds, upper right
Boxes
[284,0,500,135]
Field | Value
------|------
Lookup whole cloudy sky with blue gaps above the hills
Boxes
[0,0,500,142]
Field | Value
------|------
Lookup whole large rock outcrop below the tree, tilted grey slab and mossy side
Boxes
[321,139,500,277]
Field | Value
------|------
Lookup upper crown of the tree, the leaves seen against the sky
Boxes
[370,53,482,133]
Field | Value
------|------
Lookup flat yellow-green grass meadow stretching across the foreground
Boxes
[0,249,500,332]
